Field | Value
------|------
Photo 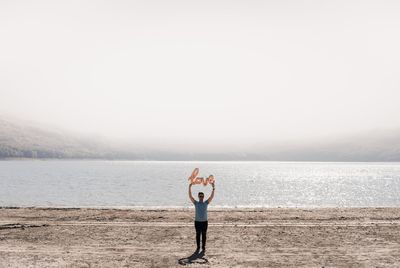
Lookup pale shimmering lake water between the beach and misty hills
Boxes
[0,160,400,207]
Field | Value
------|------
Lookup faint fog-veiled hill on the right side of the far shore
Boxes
[248,130,400,162]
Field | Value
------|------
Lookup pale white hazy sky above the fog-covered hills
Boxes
[0,0,400,147]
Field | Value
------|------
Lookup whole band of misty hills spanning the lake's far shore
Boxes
[0,117,400,161]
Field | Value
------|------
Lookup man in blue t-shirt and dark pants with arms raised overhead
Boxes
[189,183,215,253]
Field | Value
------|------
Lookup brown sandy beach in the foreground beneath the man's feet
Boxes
[0,208,400,267]
